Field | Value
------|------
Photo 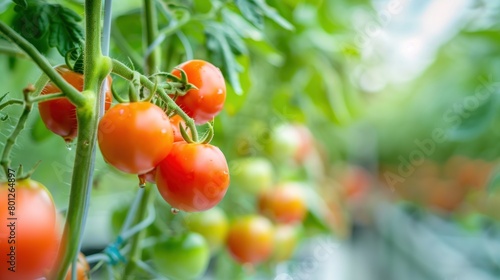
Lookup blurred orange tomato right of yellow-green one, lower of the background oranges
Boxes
[227,215,274,264]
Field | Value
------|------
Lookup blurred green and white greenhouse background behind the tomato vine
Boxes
[0,0,500,280]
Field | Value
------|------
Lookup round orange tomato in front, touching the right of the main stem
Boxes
[97,102,173,174]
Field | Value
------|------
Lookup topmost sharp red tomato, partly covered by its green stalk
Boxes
[172,60,226,124]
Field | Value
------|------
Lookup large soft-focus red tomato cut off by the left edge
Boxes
[0,179,60,279]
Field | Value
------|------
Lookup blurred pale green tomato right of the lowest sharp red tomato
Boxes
[230,157,274,194]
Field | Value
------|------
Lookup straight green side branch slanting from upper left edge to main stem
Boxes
[0,21,85,107]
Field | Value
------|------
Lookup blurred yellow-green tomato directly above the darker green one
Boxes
[185,207,229,254]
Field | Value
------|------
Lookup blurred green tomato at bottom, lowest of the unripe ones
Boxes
[153,232,210,280]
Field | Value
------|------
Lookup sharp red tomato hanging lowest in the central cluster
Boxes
[156,142,229,212]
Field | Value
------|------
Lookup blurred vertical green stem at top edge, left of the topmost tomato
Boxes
[143,0,160,75]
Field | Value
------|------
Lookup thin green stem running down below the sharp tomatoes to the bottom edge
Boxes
[123,186,152,279]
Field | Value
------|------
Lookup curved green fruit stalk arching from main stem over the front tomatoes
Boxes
[113,59,198,142]
